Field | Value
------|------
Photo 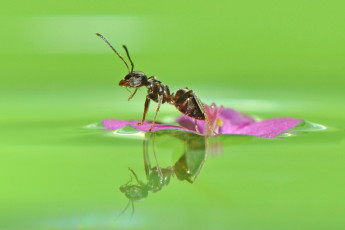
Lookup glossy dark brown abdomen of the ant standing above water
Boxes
[174,88,205,120]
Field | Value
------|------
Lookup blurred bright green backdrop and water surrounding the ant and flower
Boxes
[0,0,345,229]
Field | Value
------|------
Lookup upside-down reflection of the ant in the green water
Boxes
[120,131,209,215]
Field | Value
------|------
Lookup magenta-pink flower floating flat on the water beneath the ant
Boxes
[102,104,302,138]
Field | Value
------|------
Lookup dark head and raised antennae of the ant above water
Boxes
[96,33,147,88]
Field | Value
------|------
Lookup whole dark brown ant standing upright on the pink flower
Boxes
[96,33,216,135]
